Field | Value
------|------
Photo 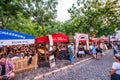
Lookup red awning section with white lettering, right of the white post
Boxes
[52,33,69,42]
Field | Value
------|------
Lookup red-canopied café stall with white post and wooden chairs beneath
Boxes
[35,33,69,62]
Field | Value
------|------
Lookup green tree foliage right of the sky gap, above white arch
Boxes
[68,0,120,36]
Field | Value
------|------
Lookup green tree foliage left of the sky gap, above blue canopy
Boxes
[0,0,57,36]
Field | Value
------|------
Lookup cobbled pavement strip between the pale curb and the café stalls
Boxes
[15,55,91,80]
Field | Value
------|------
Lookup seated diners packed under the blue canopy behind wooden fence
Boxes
[0,44,35,60]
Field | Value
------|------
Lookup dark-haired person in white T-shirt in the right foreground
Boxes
[109,54,120,80]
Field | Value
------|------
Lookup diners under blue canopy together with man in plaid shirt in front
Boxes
[0,44,35,80]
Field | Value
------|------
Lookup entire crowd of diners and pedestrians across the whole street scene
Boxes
[0,42,120,80]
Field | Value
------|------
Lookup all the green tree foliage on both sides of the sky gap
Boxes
[0,0,120,37]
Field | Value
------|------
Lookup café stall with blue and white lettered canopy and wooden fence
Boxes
[0,30,37,72]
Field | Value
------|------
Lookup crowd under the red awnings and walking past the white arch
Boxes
[38,42,110,64]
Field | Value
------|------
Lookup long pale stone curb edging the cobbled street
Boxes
[34,57,92,80]
